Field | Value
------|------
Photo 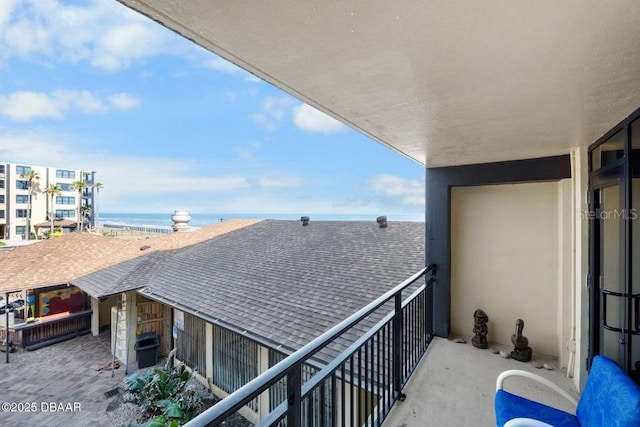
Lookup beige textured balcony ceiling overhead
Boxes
[120,0,640,167]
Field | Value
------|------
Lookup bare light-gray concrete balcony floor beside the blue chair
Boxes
[384,338,579,427]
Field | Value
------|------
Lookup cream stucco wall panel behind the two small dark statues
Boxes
[451,180,573,365]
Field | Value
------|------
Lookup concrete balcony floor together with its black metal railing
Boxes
[179,265,579,426]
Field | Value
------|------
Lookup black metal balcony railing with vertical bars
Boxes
[186,264,437,427]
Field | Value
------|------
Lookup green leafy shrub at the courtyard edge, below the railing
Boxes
[125,365,201,427]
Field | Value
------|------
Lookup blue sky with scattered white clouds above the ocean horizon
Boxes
[0,0,424,215]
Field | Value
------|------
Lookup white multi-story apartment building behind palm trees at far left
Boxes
[0,161,95,240]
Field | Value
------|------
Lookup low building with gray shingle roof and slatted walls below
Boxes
[70,220,426,426]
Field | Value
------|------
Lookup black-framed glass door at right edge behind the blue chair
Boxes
[587,110,640,380]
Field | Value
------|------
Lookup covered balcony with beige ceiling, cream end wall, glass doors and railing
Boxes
[106,0,640,425]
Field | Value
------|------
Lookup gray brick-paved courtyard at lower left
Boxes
[0,333,131,427]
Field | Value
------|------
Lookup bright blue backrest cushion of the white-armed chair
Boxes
[576,356,640,427]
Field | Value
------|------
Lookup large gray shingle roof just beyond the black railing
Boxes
[79,220,425,362]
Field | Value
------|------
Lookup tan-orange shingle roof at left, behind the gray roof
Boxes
[0,220,257,291]
